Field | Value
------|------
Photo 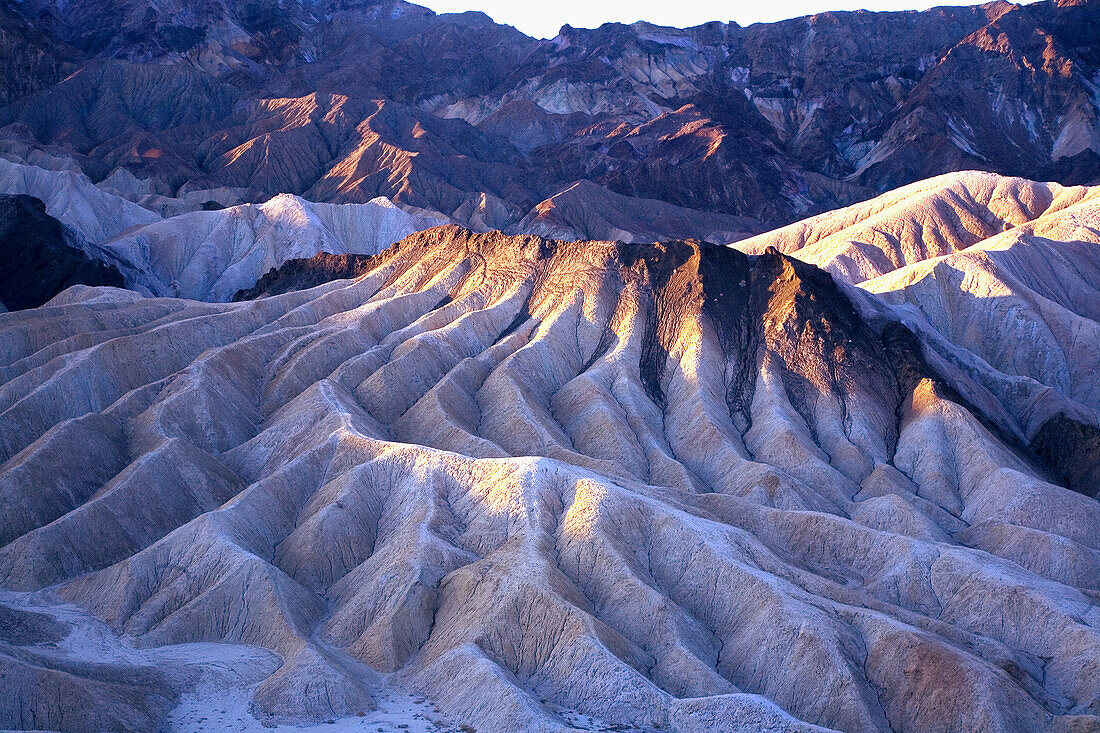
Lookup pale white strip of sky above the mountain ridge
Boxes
[413,0,998,39]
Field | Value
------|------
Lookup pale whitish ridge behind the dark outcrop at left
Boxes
[0,158,447,307]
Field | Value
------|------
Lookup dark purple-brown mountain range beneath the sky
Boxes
[0,0,1100,241]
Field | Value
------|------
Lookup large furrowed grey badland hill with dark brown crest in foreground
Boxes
[0,227,1100,731]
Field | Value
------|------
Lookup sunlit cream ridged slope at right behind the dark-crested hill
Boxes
[737,168,1100,494]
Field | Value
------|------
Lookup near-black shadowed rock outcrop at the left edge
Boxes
[0,195,123,310]
